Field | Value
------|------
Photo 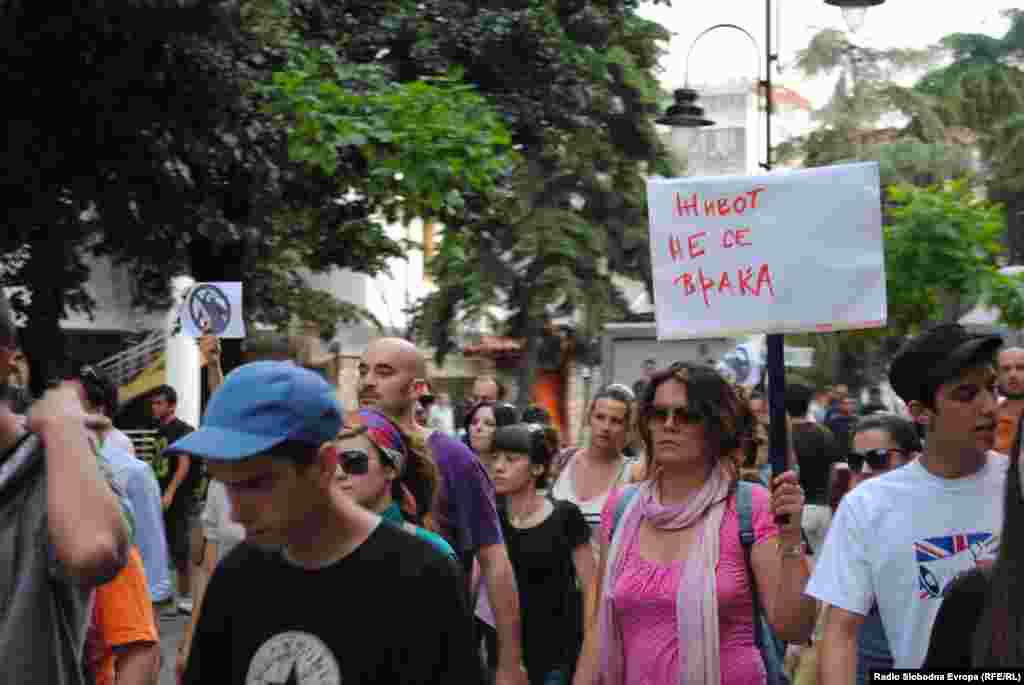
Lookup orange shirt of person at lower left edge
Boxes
[93,547,160,685]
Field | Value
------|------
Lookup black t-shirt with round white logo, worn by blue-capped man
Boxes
[184,518,483,685]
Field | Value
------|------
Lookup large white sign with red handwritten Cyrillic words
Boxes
[647,162,886,340]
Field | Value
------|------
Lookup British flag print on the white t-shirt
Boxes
[913,532,999,599]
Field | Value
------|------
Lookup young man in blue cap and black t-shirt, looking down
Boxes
[172,361,482,685]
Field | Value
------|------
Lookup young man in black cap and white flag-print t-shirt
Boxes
[807,325,1007,685]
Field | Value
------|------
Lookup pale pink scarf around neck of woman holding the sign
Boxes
[598,468,729,685]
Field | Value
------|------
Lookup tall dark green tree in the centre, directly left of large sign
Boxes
[407,0,671,403]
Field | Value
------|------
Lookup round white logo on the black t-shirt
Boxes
[246,631,341,685]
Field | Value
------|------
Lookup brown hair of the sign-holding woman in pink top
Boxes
[637,361,755,478]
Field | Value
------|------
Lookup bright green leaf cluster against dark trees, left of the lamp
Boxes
[258,13,515,218]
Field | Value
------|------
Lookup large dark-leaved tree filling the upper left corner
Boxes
[0,0,516,389]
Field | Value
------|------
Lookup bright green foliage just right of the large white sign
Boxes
[884,181,1024,332]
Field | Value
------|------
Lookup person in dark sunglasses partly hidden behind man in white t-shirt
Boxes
[839,414,923,685]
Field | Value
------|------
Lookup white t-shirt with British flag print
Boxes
[806,453,1008,669]
